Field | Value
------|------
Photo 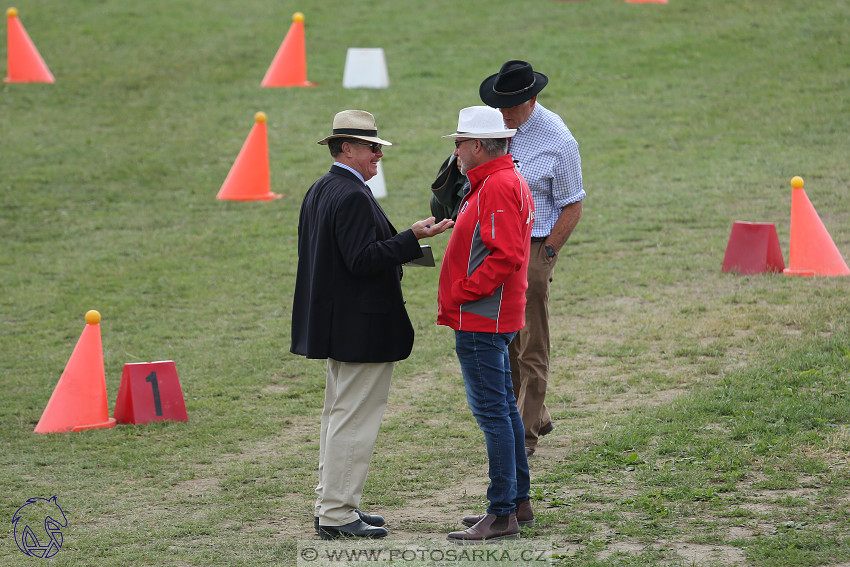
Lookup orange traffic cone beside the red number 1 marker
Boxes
[35,310,116,433]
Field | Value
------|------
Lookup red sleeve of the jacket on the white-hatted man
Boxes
[452,181,528,303]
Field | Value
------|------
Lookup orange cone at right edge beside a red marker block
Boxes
[784,176,850,276]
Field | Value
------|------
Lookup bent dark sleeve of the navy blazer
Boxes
[334,192,422,276]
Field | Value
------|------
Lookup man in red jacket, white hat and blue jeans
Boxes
[437,106,534,543]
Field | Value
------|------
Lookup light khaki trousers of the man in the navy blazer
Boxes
[315,358,395,526]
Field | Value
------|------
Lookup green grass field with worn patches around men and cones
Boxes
[0,0,850,566]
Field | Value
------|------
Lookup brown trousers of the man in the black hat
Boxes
[508,241,558,449]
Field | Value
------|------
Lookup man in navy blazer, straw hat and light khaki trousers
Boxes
[290,110,454,539]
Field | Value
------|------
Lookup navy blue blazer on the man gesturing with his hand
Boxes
[290,165,422,362]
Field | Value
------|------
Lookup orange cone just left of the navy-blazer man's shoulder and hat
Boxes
[216,112,283,201]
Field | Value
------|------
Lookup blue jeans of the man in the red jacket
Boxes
[455,331,530,516]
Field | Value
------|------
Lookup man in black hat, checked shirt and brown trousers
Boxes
[478,60,585,456]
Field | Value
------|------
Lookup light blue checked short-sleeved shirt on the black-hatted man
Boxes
[511,102,586,237]
